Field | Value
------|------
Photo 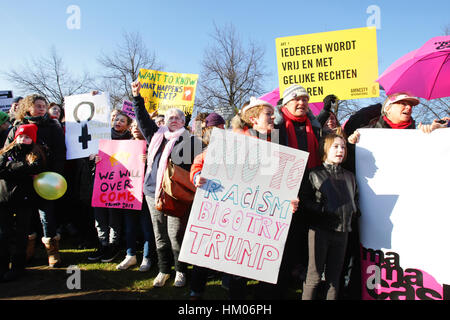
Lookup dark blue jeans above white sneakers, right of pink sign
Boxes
[125,197,156,261]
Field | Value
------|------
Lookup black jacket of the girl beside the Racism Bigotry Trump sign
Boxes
[300,163,360,232]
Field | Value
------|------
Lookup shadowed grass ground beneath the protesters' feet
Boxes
[0,241,299,300]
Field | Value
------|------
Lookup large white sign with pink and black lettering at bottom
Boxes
[356,129,450,300]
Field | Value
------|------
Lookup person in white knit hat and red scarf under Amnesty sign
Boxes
[258,84,321,299]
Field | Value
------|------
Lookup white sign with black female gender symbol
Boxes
[64,93,111,160]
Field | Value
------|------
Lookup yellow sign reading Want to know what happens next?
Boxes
[138,69,198,114]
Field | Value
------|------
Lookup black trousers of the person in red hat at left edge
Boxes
[0,204,33,272]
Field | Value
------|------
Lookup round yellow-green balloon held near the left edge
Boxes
[33,172,67,200]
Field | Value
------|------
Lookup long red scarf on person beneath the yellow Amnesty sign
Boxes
[281,108,321,169]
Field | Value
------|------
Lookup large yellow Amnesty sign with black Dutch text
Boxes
[275,27,379,102]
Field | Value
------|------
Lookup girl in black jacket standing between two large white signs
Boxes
[300,133,359,300]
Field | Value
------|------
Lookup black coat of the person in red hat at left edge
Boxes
[0,145,44,205]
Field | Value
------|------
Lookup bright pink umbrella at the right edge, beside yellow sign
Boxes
[377,36,450,100]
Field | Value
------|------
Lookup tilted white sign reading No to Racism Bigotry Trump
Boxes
[179,129,308,283]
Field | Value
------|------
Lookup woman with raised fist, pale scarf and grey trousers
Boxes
[131,81,201,287]
